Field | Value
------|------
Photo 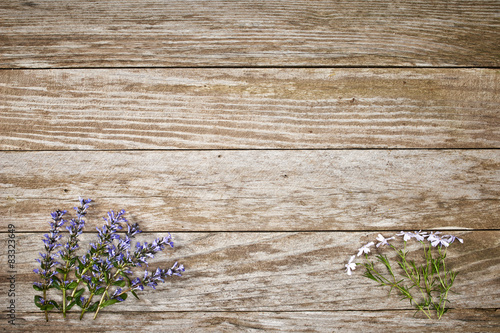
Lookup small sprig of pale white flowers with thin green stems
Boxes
[345,230,464,319]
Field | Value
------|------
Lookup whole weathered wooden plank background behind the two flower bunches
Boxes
[0,0,500,332]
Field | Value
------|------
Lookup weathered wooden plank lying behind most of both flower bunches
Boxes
[0,231,500,317]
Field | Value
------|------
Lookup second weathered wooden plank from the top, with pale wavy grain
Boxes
[0,69,500,150]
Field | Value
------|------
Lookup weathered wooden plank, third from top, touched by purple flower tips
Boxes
[0,150,500,231]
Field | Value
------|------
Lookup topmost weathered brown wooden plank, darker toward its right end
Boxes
[0,0,500,68]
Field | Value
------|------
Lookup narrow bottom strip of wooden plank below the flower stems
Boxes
[0,309,500,333]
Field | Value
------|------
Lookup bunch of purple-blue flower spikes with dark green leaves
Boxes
[33,198,184,321]
